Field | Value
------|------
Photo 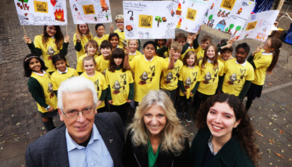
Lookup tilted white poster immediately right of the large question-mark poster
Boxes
[171,0,213,33]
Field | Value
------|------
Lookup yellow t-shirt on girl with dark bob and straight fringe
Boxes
[105,69,134,106]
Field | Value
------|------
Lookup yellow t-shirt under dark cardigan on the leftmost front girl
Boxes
[30,72,58,113]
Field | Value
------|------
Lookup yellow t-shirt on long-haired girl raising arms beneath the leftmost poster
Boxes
[34,35,63,72]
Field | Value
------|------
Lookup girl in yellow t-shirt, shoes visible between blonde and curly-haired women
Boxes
[177,51,201,122]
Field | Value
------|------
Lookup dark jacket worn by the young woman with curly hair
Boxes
[191,128,254,167]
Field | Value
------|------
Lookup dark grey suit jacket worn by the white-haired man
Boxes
[25,112,125,167]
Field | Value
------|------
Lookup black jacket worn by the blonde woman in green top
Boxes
[123,130,190,167]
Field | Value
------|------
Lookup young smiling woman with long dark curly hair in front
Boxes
[191,94,260,167]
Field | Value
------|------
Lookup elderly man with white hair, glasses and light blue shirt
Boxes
[25,77,125,167]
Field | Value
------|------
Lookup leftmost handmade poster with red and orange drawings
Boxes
[14,0,67,25]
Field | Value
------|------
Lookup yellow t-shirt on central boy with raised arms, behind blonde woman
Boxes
[129,55,169,102]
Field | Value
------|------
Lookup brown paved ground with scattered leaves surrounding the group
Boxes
[0,0,292,167]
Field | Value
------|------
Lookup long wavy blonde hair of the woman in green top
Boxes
[128,90,188,156]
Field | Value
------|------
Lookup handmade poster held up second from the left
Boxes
[70,0,112,24]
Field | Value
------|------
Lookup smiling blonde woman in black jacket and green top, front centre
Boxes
[123,90,190,167]
